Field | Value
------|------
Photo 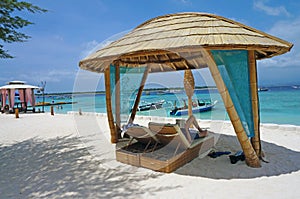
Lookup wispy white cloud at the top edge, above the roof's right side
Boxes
[254,0,290,16]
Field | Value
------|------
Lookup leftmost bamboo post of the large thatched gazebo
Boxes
[104,67,118,143]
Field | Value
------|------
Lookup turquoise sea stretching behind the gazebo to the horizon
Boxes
[37,86,300,126]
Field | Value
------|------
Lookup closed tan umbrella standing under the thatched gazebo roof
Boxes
[183,70,195,116]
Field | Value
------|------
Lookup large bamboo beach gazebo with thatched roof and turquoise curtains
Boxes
[79,12,293,167]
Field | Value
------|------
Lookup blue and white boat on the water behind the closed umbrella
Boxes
[170,100,218,116]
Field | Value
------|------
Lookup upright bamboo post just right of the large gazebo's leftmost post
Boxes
[115,64,121,138]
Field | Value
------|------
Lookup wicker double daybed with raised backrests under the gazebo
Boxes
[116,116,214,173]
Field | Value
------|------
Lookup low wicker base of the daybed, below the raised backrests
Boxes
[116,134,214,173]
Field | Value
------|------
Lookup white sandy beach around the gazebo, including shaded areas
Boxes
[0,114,300,198]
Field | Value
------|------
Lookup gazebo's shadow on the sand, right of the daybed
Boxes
[175,135,300,179]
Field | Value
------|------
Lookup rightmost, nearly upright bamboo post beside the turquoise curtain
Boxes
[248,50,262,158]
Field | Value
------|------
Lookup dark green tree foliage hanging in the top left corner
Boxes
[0,0,47,58]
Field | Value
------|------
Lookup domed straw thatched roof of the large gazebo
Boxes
[79,13,293,72]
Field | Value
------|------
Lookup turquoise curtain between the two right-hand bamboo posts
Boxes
[211,50,254,137]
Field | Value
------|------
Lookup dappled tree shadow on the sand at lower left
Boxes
[0,137,176,198]
